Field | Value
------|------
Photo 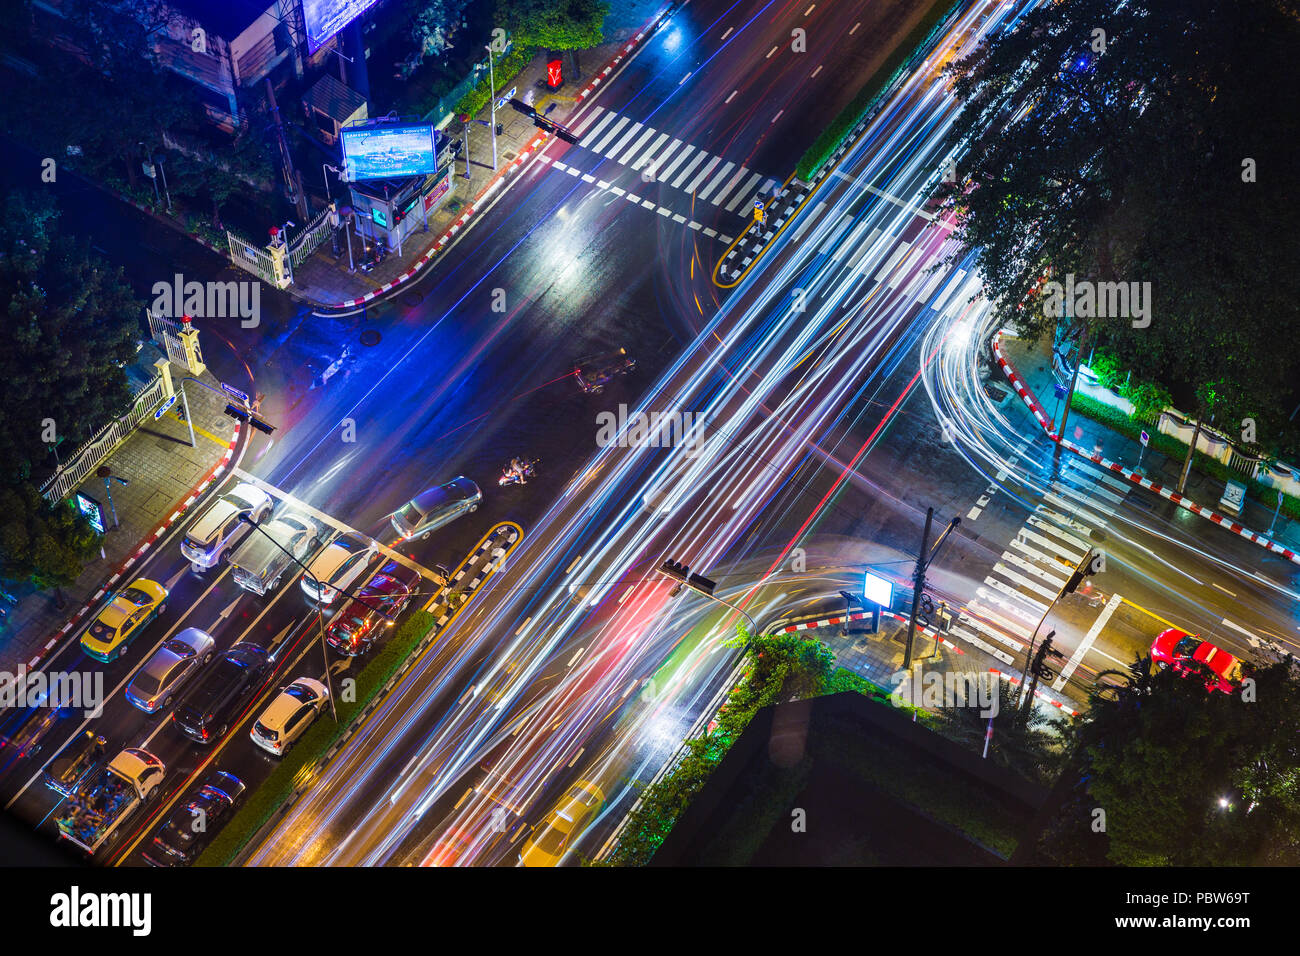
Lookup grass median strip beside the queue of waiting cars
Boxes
[194,611,436,866]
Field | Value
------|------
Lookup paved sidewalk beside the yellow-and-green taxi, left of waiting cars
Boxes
[0,361,239,672]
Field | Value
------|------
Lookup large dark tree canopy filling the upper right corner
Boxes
[937,0,1300,454]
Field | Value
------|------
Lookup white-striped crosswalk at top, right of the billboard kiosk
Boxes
[573,105,781,216]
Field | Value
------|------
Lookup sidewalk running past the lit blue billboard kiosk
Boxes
[286,0,671,310]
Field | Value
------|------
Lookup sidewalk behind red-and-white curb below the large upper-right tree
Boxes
[997,336,1300,561]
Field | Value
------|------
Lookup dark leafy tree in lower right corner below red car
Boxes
[1040,659,1300,866]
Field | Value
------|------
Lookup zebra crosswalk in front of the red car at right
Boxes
[961,455,1128,652]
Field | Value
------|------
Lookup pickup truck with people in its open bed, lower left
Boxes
[57,747,166,856]
